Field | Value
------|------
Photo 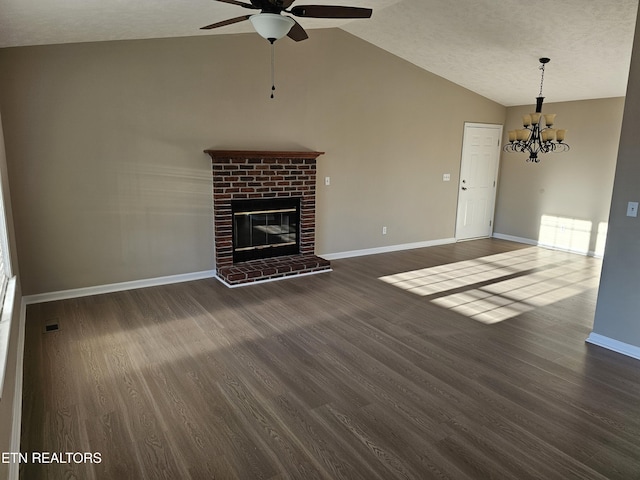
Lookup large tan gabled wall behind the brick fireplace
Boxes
[0,29,505,294]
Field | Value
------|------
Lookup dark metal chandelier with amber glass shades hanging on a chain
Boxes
[504,58,569,163]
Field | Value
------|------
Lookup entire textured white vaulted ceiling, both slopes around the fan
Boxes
[0,0,638,106]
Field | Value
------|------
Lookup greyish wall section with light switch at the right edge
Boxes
[593,9,640,346]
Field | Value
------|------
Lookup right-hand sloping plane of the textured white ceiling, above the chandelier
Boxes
[344,0,638,106]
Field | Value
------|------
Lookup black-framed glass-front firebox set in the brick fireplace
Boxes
[231,198,300,263]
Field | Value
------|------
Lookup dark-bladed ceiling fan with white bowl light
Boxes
[201,0,373,44]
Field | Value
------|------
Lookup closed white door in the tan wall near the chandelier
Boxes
[456,123,502,240]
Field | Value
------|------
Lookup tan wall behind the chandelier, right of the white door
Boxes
[494,98,624,253]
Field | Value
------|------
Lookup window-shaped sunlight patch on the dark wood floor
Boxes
[379,247,601,324]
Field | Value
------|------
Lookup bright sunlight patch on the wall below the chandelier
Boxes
[538,215,608,257]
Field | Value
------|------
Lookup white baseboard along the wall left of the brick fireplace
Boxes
[23,270,216,305]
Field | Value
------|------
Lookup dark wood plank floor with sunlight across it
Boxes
[21,240,640,480]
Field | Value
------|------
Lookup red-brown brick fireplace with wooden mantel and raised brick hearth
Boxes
[205,150,331,286]
